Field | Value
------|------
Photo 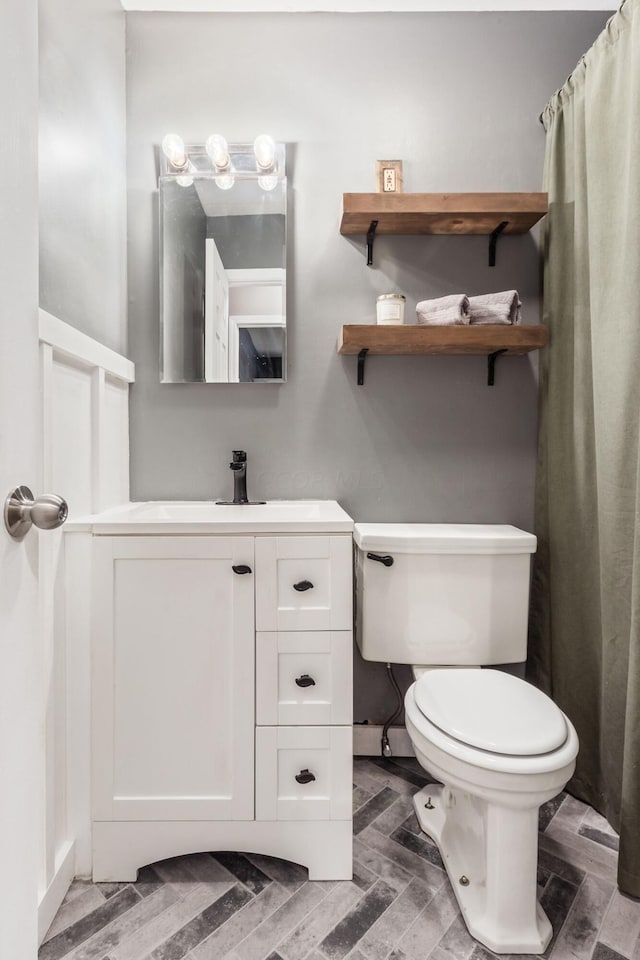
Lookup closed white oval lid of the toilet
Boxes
[414,669,567,757]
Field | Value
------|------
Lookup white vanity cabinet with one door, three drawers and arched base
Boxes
[84,505,353,881]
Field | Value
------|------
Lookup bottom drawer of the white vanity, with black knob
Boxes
[256,727,353,820]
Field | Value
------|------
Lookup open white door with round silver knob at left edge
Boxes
[0,0,44,960]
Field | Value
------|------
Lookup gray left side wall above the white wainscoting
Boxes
[38,0,127,353]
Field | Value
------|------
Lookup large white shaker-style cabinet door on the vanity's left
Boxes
[92,537,254,820]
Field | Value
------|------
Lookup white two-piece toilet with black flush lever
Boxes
[355,523,578,953]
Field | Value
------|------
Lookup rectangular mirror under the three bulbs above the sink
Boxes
[160,145,287,383]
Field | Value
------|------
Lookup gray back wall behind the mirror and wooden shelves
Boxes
[127,13,606,719]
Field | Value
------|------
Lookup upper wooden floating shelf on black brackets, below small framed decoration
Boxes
[340,193,548,236]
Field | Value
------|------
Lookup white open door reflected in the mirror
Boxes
[204,239,229,383]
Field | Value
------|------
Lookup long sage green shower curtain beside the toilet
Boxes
[530,0,640,897]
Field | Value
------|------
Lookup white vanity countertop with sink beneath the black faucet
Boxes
[65,500,353,536]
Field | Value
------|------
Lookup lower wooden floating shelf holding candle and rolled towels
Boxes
[338,323,547,386]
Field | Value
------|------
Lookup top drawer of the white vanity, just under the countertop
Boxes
[256,537,353,631]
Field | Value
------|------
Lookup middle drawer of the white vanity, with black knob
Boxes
[256,630,353,726]
